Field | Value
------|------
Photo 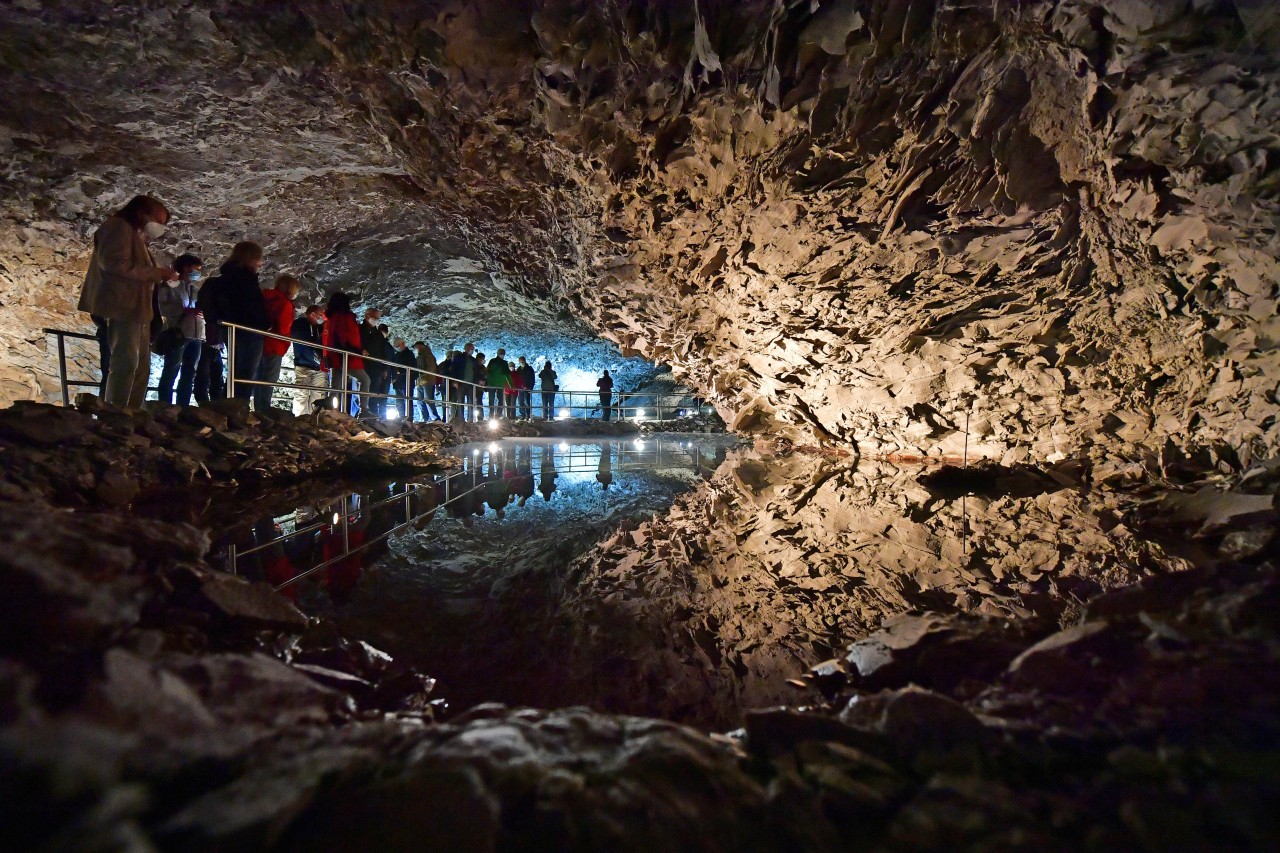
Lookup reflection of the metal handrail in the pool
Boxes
[227,447,721,590]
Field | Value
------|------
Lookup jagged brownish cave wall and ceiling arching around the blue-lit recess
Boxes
[0,0,1280,462]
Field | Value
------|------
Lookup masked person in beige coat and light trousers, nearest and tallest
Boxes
[79,196,178,409]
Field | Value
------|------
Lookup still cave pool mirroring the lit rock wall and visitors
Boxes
[207,438,1174,727]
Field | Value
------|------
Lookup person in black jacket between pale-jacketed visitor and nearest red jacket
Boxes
[205,240,271,400]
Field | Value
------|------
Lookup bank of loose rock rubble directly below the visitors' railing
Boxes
[0,394,454,507]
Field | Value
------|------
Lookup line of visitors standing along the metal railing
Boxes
[79,196,613,420]
